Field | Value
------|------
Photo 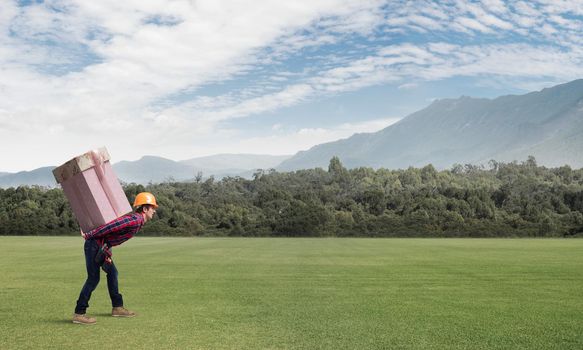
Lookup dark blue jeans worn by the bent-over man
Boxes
[75,239,123,314]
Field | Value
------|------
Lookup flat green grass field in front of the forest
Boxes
[0,237,583,349]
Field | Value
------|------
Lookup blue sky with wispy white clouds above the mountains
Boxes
[0,0,583,172]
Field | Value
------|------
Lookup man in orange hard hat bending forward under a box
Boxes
[73,192,158,325]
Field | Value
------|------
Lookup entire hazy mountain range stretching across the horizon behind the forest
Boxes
[0,79,583,187]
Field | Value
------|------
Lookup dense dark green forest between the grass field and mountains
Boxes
[0,157,583,237]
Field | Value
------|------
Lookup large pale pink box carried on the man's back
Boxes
[53,147,132,232]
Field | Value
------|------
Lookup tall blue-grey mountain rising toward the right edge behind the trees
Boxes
[277,79,583,171]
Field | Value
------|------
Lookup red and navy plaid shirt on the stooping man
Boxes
[86,213,144,247]
